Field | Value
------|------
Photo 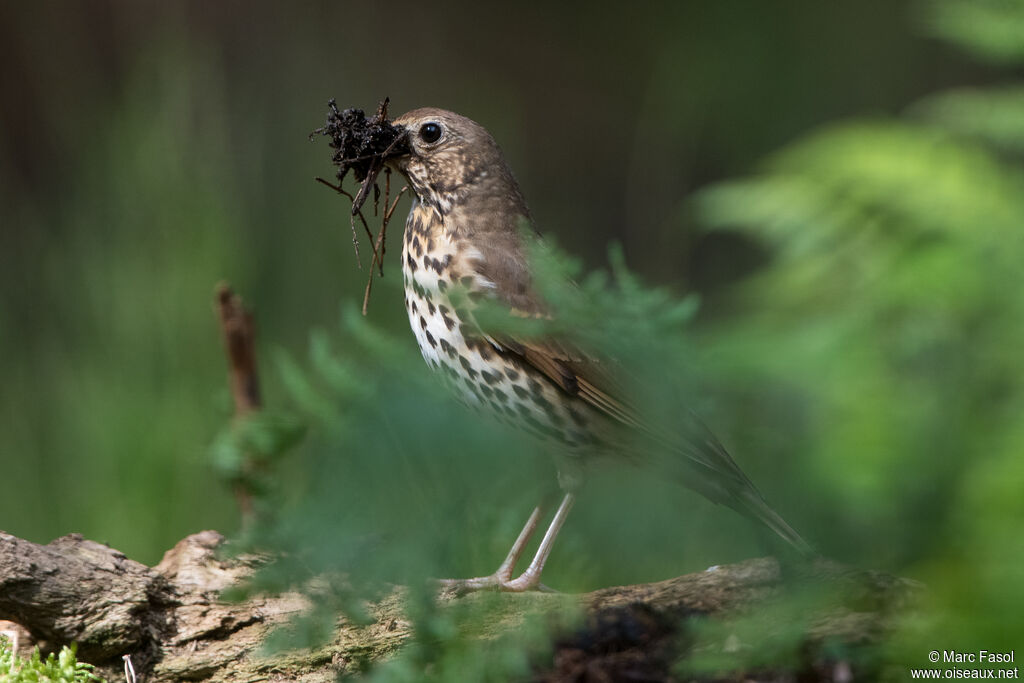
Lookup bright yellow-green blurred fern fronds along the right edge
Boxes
[695,2,1024,680]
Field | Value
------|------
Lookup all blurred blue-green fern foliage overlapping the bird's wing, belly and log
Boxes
[231,259,724,681]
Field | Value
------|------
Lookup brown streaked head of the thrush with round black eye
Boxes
[388,108,521,213]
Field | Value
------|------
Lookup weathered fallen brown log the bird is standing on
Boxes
[0,531,915,683]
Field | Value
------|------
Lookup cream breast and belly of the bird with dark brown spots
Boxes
[401,203,593,450]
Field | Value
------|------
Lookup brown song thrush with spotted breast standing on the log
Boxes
[388,109,809,591]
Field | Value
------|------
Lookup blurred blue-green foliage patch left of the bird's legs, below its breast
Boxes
[227,305,581,681]
